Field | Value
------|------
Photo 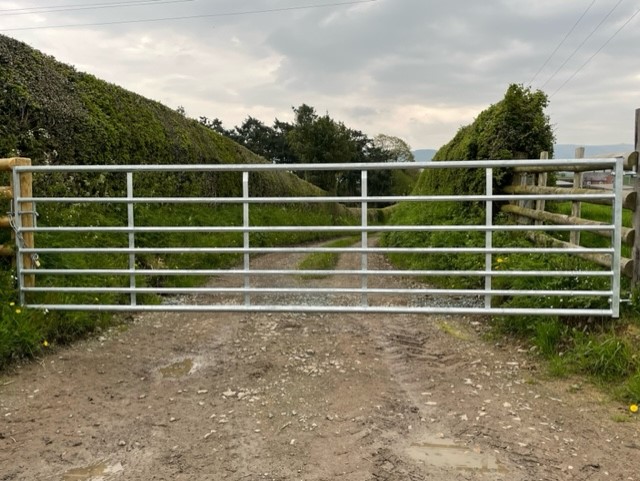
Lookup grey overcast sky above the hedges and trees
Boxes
[0,0,640,149]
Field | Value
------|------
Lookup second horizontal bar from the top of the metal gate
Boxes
[17,191,614,204]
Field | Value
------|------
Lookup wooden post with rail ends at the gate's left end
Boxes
[0,157,35,287]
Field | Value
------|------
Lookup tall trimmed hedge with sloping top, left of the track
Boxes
[0,35,317,200]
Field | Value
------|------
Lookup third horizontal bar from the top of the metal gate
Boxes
[21,224,615,233]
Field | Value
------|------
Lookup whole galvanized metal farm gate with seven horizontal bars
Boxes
[13,158,623,317]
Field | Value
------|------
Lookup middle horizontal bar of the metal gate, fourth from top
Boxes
[21,247,615,255]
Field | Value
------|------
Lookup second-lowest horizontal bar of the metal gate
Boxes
[24,286,613,297]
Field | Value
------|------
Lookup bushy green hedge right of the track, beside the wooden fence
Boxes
[382,85,553,287]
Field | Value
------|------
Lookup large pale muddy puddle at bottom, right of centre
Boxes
[407,439,501,472]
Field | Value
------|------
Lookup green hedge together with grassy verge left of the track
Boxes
[0,35,360,367]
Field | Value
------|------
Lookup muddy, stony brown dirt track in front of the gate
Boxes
[0,249,640,481]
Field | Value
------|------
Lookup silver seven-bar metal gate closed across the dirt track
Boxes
[13,157,624,317]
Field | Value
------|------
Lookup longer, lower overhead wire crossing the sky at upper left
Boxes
[0,0,378,32]
